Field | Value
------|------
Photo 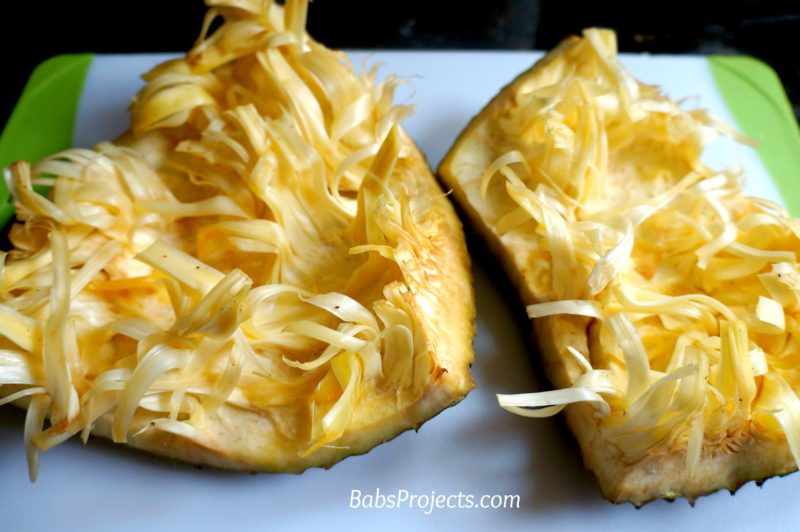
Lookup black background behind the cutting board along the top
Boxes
[0,0,800,131]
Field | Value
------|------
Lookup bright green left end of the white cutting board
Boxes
[0,54,93,226]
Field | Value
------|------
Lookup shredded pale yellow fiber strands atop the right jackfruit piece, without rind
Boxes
[496,29,800,475]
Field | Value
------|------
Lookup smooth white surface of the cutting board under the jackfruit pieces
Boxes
[0,52,800,531]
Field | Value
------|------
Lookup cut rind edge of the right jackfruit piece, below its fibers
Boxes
[437,36,797,507]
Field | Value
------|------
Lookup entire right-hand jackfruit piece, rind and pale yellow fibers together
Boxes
[438,30,800,505]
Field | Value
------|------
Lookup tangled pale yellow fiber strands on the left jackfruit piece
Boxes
[0,0,430,479]
